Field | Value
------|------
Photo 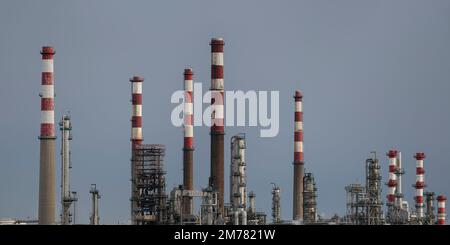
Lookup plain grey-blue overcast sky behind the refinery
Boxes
[0,0,450,224]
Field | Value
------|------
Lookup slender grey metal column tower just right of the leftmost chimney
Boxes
[59,115,78,225]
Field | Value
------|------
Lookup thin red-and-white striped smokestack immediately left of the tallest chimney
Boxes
[183,69,194,215]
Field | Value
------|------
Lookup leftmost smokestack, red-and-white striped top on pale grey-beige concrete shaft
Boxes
[38,46,56,225]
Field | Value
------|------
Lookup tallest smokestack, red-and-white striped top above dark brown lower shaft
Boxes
[210,38,225,215]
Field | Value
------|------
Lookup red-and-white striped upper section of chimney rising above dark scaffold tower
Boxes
[130,76,144,150]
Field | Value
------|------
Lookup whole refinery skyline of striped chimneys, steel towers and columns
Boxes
[22,38,447,225]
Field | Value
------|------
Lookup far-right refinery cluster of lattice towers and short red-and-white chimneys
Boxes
[343,149,445,225]
